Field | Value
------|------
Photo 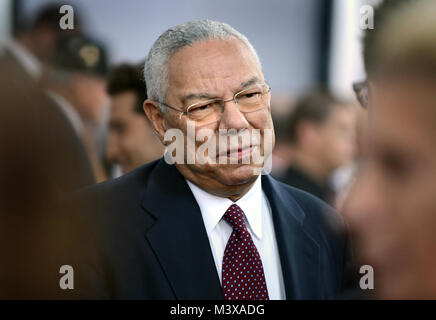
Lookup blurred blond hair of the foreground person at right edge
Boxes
[369,0,436,79]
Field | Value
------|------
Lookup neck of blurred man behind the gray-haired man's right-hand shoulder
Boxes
[291,149,330,184]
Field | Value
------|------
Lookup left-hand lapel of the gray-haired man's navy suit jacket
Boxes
[142,159,223,299]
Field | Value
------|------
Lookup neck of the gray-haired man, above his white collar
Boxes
[176,164,258,202]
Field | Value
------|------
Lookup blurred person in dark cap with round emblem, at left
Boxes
[42,34,108,181]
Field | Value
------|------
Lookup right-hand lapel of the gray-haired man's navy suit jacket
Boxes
[262,175,321,299]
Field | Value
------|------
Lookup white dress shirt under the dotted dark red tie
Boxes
[186,176,286,300]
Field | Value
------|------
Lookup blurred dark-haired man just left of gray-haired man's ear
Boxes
[106,64,164,173]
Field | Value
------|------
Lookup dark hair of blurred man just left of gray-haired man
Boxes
[107,63,147,116]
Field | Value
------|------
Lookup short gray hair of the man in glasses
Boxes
[144,20,260,111]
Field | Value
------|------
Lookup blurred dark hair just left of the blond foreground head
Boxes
[363,0,415,76]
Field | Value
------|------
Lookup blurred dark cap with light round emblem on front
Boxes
[53,34,108,77]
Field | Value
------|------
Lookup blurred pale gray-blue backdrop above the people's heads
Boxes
[0,0,374,97]
